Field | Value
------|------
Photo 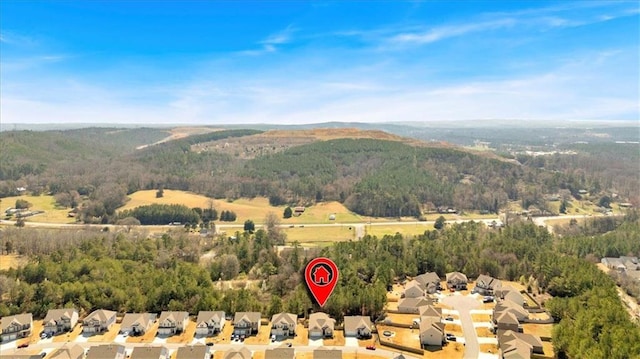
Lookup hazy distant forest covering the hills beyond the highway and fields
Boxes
[0,129,639,223]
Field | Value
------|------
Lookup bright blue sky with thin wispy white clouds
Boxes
[0,0,640,124]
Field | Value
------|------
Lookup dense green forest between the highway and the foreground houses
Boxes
[0,216,640,358]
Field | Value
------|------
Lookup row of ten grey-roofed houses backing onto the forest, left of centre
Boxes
[0,308,372,342]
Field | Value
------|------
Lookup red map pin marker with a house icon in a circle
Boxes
[304,257,339,307]
